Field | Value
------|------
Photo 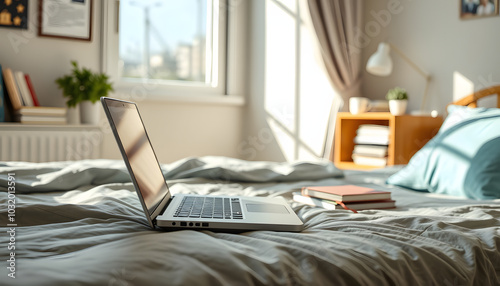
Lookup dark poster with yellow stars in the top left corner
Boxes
[0,0,28,30]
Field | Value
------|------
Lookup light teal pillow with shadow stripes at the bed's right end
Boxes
[387,105,500,200]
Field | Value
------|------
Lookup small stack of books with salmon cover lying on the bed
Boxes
[293,185,396,212]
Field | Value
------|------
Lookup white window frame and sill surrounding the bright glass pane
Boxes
[101,0,242,100]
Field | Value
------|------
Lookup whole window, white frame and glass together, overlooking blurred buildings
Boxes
[103,0,232,98]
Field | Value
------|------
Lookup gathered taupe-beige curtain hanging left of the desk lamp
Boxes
[308,0,363,110]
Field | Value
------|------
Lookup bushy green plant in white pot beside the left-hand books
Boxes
[55,61,113,124]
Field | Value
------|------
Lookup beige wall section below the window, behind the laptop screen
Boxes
[98,98,243,163]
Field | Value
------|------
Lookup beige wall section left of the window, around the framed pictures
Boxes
[0,1,101,106]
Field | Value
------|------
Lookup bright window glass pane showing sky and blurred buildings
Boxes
[119,0,211,84]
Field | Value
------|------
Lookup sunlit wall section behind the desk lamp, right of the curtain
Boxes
[361,0,500,114]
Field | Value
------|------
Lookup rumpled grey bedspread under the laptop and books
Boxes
[0,157,500,286]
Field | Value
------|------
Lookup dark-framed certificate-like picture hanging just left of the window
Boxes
[38,0,92,41]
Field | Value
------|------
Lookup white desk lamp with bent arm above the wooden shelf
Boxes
[366,42,431,114]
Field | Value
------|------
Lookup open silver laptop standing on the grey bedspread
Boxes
[101,97,303,232]
